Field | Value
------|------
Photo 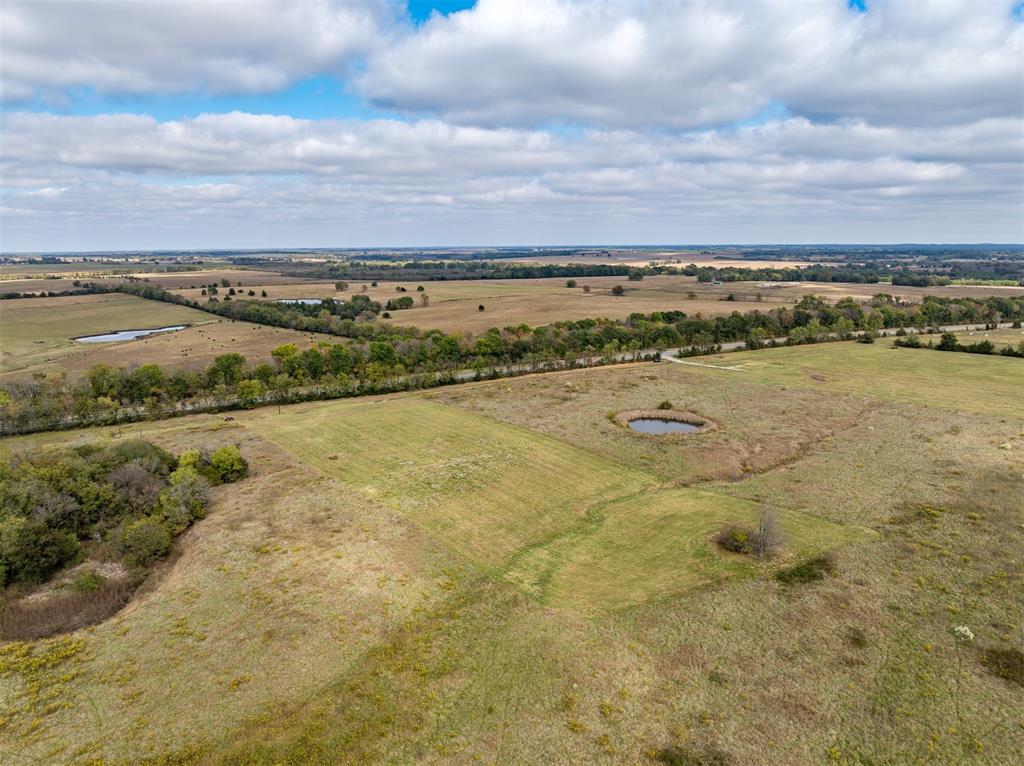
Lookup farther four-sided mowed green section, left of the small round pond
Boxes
[248,397,656,567]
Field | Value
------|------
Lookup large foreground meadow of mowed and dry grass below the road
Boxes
[0,341,1024,766]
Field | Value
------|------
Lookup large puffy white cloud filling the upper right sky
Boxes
[358,0,1024,128]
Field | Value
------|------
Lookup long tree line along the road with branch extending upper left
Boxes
[0,285,1024,433]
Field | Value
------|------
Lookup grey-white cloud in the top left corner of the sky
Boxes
[0,0,395,101]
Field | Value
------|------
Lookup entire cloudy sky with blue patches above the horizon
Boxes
[0,0,1024,252]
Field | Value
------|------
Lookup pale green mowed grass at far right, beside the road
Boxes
[679,334,1024,415]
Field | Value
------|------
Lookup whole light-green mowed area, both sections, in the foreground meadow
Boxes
[247,398,862,612]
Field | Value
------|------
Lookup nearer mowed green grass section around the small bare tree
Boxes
[508,487,872,612]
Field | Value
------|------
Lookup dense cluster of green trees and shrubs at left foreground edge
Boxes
[0,439,247,585]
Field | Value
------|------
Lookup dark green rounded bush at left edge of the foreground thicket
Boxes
[0,516,79,583]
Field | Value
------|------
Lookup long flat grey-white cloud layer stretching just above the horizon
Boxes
[2,113,1024,247]
